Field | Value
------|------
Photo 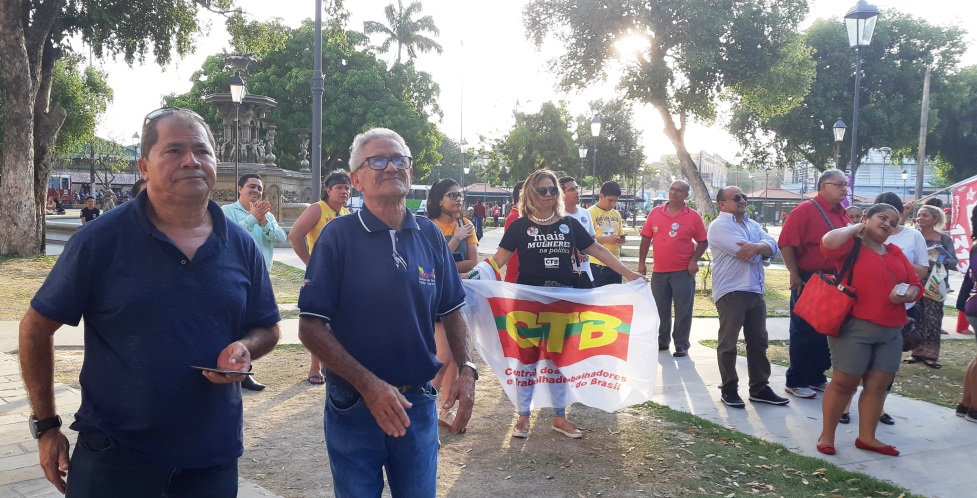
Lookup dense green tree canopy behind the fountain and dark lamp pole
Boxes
[167,19,441,176]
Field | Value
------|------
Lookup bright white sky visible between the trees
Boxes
[89,0,977,164]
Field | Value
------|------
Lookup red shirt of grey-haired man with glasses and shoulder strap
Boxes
[777,194,851,272]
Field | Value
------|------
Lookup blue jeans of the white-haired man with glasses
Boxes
[323,382,438,498]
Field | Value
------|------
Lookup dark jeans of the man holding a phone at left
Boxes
[65,431,238,498]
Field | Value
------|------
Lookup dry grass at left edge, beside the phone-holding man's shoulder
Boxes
[0,256,58,320]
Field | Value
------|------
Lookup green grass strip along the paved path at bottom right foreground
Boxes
[639,403,920,497]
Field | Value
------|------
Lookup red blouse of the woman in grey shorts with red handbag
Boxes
[824,237,923,327]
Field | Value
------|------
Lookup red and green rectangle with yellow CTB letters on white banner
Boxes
[488,298,634,367]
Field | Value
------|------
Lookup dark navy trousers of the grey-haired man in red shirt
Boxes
[787,278,831,387]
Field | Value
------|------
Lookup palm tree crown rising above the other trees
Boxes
[363,0,443,63]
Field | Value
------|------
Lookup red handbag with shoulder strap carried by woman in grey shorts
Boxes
[794,237,862,337]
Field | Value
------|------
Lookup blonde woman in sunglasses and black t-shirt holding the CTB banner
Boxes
[492,169,646,439]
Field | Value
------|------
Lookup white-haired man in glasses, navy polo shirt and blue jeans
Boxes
[299,128,478,497]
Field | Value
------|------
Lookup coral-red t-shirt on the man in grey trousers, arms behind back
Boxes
[641,203,708,272]
